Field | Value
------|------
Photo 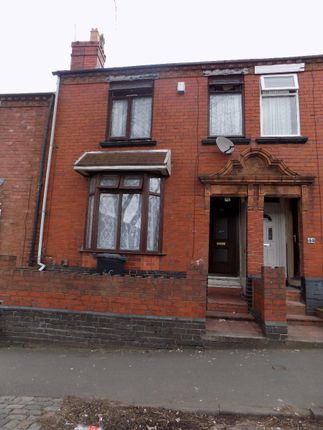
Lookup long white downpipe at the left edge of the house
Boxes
[37,76,60,272]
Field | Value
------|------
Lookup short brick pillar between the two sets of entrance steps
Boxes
[253,266,288,340]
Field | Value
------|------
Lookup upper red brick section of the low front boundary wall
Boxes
[0,269,206,318]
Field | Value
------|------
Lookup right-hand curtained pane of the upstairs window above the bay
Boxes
[130,97,152,138]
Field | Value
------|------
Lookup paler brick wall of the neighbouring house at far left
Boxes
[0,94,52,266]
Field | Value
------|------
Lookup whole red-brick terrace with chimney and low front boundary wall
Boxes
[0,30,323,345]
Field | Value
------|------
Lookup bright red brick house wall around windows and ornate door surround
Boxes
[41,64,323,277]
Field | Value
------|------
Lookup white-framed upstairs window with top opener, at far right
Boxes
[260,74,300,136]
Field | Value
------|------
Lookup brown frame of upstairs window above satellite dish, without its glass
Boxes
[208,76,245,138]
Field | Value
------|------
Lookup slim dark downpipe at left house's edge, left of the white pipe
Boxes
[28,94,55,266]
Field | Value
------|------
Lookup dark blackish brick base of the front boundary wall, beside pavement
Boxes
[0,306,205,348]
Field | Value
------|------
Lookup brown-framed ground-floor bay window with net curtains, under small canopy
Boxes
[85,174,163,253]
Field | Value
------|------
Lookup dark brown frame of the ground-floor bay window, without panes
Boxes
[84,172,164,254]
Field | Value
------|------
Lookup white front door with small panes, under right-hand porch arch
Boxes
[264,202,286,269]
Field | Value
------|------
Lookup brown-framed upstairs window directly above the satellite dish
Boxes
[209,77,243,136]
